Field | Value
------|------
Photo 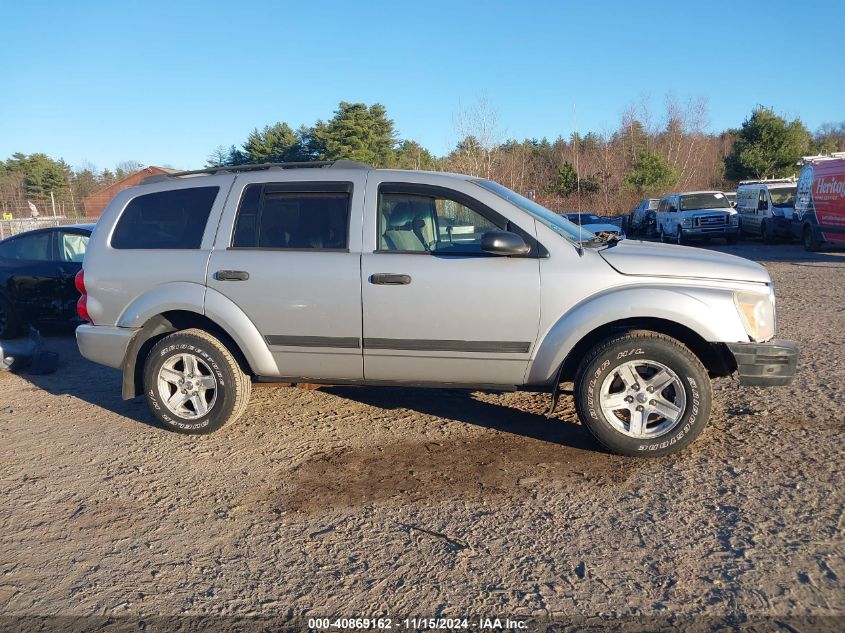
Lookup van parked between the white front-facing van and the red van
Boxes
[736,178,797,244]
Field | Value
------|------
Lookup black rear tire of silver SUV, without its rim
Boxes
[144,333,236,434]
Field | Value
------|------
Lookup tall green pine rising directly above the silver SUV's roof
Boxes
[305,101,396,167]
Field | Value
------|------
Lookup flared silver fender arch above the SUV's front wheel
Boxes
[525,284,748,385]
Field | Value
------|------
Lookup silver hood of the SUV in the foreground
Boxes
[599,240,771,283]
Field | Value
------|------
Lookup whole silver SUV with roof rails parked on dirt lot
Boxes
[77,161,798,455]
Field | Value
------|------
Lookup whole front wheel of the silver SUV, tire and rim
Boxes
[575,330,712,457]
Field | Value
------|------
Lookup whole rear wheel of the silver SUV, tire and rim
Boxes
[144,329,252,435]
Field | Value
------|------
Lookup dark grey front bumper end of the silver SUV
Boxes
[727,340,798,387]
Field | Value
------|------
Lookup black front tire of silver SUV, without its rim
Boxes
[575,337,712,456]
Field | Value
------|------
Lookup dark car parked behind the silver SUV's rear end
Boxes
[0,224,94,339]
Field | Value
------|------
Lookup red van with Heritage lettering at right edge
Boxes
[790,152,845,251]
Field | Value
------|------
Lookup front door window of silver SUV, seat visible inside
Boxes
[378,192,508,255]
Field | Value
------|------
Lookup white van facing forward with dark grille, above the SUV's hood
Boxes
[657,191,739,244]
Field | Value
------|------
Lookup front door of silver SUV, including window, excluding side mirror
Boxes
[361,175,540,385]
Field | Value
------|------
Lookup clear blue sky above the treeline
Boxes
[0,0,845,169]
